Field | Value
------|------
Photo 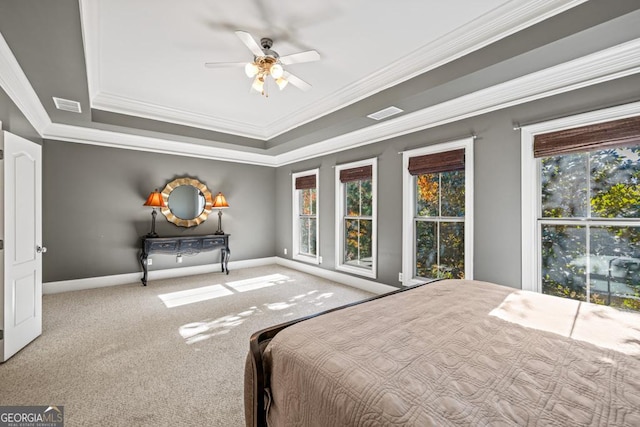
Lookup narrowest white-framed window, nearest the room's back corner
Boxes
[292,169,320,264]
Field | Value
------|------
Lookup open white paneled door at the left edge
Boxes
[0,132,46,362]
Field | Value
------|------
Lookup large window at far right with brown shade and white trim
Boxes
[523,108,640,310]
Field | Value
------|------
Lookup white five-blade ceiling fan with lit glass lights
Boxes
[204,31,320,96]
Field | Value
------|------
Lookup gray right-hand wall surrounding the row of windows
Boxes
[276,76,640,288]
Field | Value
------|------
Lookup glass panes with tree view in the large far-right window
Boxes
[539,146,640,310]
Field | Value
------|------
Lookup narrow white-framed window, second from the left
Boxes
[336,159,377,278]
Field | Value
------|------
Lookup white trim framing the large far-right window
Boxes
[520,102,640,292]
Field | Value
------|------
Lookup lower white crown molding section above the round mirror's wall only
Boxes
[42,123,277,167]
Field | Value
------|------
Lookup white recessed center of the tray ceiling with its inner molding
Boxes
[80,0,581,140]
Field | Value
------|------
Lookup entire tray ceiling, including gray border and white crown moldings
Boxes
[6,0,640,167]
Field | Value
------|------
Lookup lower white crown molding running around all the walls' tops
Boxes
[0,21,640,167]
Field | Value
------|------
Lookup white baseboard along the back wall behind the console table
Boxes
[42,257,276,294]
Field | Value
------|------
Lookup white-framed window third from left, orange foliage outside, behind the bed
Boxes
[402,138,473,285]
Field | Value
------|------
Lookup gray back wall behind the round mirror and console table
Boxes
[43,140,275,282]
